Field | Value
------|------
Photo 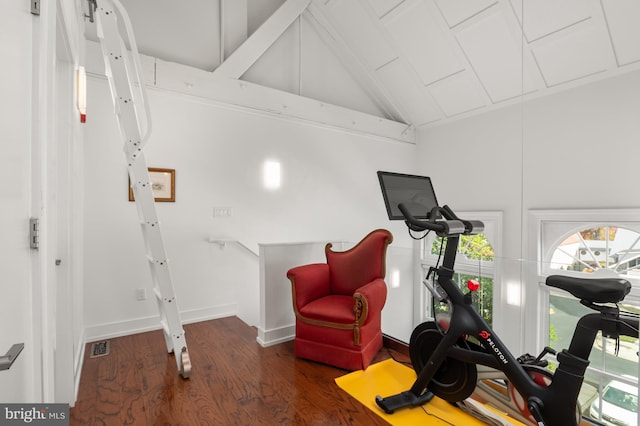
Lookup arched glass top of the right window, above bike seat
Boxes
[549,225,640,278]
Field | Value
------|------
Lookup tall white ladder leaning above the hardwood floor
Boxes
[90,0,191,378]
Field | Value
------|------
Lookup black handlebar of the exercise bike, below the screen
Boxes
[398,203,484,237]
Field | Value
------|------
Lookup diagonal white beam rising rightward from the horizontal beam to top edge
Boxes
[213,0,311,78]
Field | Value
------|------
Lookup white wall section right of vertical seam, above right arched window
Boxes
[523,71,640,209]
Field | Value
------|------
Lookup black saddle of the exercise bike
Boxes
[546,275,631,303]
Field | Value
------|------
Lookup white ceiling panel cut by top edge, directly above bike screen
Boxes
[383,0,464,84]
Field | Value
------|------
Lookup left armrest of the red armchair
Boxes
[287,263,329,312]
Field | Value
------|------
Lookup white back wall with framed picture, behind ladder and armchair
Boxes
[84,73,416,339]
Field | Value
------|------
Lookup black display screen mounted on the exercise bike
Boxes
[378,171,438,220]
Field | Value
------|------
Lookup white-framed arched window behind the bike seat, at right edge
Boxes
[532,210,640,425]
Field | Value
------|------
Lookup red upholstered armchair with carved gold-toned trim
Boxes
[287,229,393,370]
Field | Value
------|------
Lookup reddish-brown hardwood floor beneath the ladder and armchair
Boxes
[70,317,408,426]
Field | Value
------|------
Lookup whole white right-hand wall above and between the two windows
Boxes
[418,71,640,349]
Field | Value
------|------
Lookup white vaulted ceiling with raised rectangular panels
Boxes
[87,0,640,127]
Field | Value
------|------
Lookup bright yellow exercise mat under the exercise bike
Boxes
[336,359,522,426]
